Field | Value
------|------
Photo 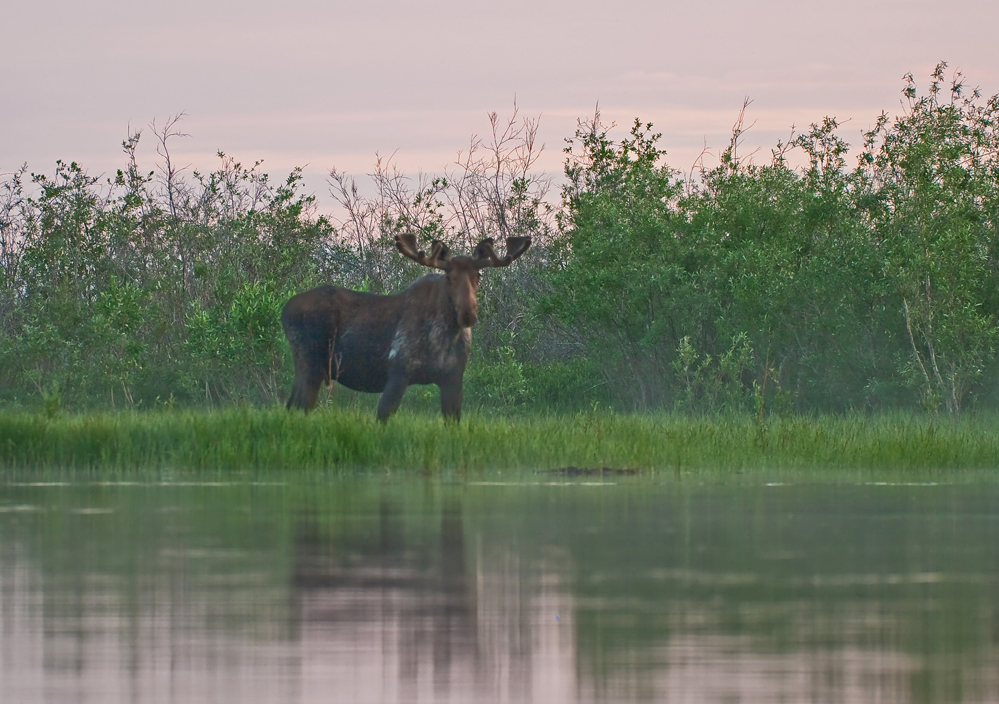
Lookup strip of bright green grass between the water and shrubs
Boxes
[0,408,999,473]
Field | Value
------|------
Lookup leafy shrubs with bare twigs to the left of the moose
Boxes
[0,129,334,406]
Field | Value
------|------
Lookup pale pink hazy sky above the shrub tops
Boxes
[0,0,999,209]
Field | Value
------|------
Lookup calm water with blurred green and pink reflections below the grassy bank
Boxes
[0,476,999,704]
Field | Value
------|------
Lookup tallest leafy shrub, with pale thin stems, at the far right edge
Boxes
[861,64,999,414]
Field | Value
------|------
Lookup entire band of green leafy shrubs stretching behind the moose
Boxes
[0,64,999,418]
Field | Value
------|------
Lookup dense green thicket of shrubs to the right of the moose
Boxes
[547,64,999,414]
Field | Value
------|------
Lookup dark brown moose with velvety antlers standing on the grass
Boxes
[281,233,531,422]
